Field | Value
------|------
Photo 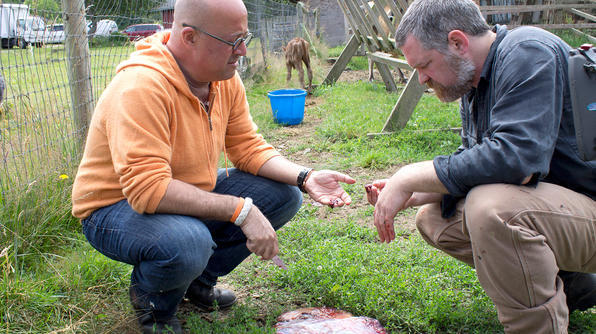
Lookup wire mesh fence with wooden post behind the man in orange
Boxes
[0,0,316,213]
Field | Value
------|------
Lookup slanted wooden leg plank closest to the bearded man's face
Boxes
[382,71,424,132]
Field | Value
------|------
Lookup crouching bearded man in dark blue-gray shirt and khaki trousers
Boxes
[367,0,596,333]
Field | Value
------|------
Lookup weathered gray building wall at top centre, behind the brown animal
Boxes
[304,0,349,47]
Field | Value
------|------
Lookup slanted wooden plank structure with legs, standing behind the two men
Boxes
[323,0,424,135]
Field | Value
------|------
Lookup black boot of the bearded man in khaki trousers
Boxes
[559,270,596,313]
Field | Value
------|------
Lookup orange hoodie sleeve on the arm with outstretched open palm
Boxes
[225,74,280,175]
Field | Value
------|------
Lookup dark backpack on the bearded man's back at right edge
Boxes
[569,44,596,161]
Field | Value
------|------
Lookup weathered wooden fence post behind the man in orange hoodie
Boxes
[62,0,93,151]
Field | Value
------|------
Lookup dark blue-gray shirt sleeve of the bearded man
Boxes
[434,40,565,196]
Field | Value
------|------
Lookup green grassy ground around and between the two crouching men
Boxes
[0,30,596,333]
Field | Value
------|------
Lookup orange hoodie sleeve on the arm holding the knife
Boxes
[102,70,172,213]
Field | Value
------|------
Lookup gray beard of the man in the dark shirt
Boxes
[427,53,476,102]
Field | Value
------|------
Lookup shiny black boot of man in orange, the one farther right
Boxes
[186,281,236,312]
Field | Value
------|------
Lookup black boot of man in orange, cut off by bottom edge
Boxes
[128,286,182,334]
